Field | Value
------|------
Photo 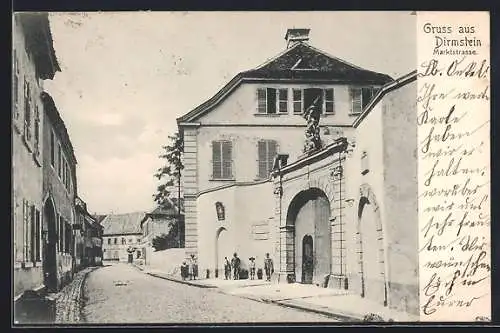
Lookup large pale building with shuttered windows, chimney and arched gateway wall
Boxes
[178,29,418,313]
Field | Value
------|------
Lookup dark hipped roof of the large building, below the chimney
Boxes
[177,42,393,124]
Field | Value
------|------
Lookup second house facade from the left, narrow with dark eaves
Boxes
[41,92,77,290]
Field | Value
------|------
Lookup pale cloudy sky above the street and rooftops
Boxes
[44,12,417,214]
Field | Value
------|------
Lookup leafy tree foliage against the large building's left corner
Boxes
[153,133,184,206]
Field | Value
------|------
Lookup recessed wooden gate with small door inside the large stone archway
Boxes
[287,188,332,285]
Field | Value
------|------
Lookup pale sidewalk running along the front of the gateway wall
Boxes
[143,270,419,322]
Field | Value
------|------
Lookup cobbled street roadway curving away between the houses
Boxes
[83,264,335,324]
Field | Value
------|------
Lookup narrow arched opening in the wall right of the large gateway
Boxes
[357,184,387,306]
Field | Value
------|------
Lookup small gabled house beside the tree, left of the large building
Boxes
[140,200,184,265]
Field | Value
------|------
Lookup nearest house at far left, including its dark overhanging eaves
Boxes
[11,14,60,299]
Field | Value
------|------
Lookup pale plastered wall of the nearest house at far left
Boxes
[11,19,43,295]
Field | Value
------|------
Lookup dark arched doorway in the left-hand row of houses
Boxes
[43,198,57,292]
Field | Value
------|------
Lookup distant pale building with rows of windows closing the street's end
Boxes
[101,212,146,263]
